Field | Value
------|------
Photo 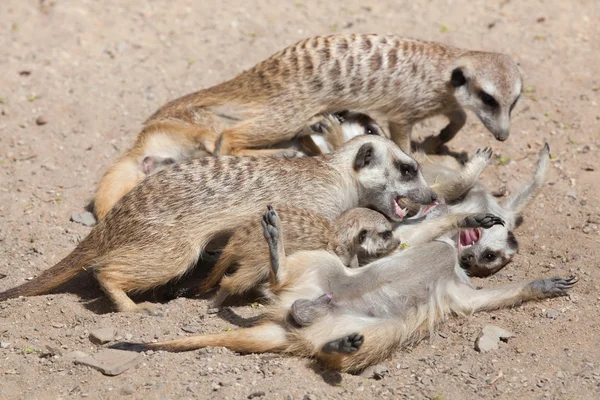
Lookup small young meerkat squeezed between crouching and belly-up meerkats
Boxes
[200,207,400,307]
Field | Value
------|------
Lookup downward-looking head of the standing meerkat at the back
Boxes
[449,51,523,141]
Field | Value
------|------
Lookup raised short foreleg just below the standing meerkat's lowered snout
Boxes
[431,147,492,201]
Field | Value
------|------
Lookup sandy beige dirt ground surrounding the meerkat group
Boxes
[0,0,600,399]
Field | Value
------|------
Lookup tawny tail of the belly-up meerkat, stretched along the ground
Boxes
[110,322,287,353]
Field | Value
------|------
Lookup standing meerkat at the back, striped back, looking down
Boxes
[94,34,522,218]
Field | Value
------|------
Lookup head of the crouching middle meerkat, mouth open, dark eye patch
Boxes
[340,135,437,221]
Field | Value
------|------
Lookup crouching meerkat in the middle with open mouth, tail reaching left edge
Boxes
[0,135,437,311]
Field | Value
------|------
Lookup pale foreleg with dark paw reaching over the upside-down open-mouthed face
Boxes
[394,214,504,246]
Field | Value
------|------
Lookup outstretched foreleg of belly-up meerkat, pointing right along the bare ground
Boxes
[455,276,578,313]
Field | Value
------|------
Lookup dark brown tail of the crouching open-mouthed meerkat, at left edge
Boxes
[0,249,92,301]
